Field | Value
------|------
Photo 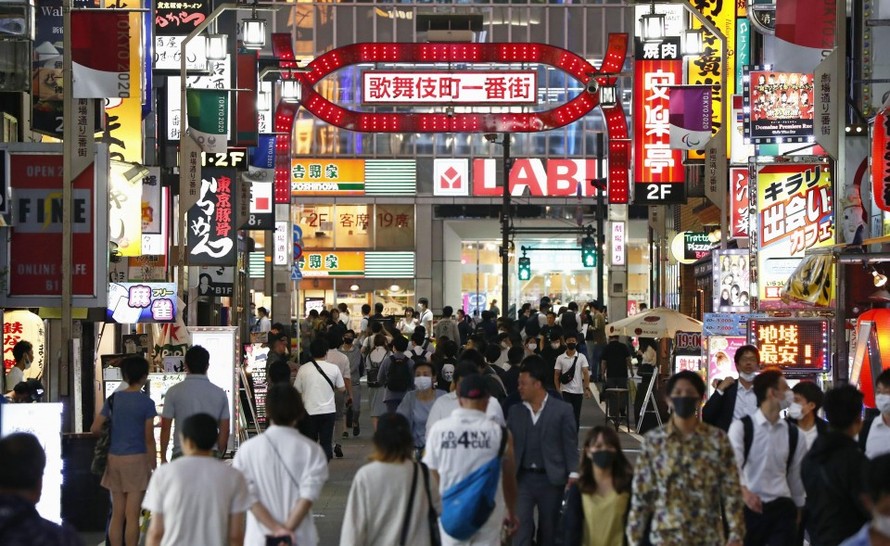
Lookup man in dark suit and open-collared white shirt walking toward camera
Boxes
[507,355,578,546]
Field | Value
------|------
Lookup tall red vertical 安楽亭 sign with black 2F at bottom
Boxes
[633,39,686,205]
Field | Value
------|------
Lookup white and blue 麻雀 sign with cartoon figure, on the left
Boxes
[106,282,176,324]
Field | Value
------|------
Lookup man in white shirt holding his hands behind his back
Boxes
[234,384,328,546]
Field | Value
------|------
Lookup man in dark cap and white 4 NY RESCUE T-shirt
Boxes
[423,374,518,545]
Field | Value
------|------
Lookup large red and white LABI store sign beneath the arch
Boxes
[433,158,597,197]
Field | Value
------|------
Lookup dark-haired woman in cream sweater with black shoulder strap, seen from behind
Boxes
[340,413,442,546]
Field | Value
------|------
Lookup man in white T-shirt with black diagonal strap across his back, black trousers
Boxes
[294,337,346,461]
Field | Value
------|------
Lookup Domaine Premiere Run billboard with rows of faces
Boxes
[745,70,815,144]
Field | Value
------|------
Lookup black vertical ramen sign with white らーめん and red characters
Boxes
[187,168,238,265]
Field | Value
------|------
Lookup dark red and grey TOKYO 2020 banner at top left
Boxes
[71,11,130,99]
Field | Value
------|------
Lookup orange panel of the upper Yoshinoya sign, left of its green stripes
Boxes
[291,159,365,195]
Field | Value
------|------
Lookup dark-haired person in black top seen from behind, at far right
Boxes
[798,385,871,546]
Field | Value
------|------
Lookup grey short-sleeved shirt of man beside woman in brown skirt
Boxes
[161,374,230,452]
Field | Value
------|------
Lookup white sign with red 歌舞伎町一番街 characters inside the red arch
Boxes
[362,70,538,104]
